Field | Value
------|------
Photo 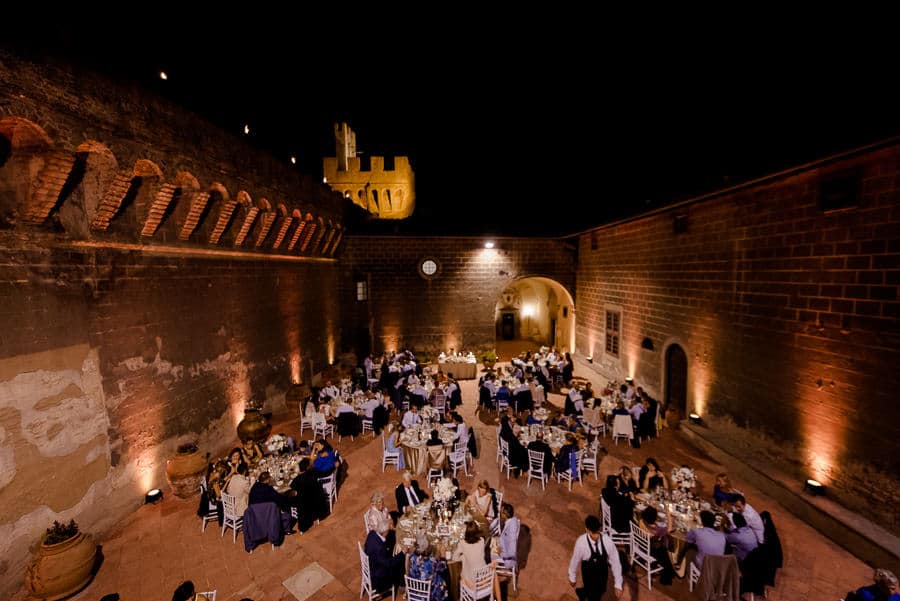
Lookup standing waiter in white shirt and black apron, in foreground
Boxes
[569,515,622,601]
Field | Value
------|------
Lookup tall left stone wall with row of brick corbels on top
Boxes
[0,54,347,598]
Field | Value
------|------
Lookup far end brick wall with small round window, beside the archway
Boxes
[340,236,575,352]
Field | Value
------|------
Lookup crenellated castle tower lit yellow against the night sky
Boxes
[322,123,416,219]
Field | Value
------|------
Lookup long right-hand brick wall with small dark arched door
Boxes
[576,146,900,530]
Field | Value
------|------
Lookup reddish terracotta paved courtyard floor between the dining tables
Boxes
[31,366,871,601]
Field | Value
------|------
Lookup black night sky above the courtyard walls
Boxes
[0,15,900,235]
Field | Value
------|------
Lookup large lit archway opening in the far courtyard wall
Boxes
[494,277,575,352]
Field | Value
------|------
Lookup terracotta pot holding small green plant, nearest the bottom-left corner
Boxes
[25,532,97,600]
